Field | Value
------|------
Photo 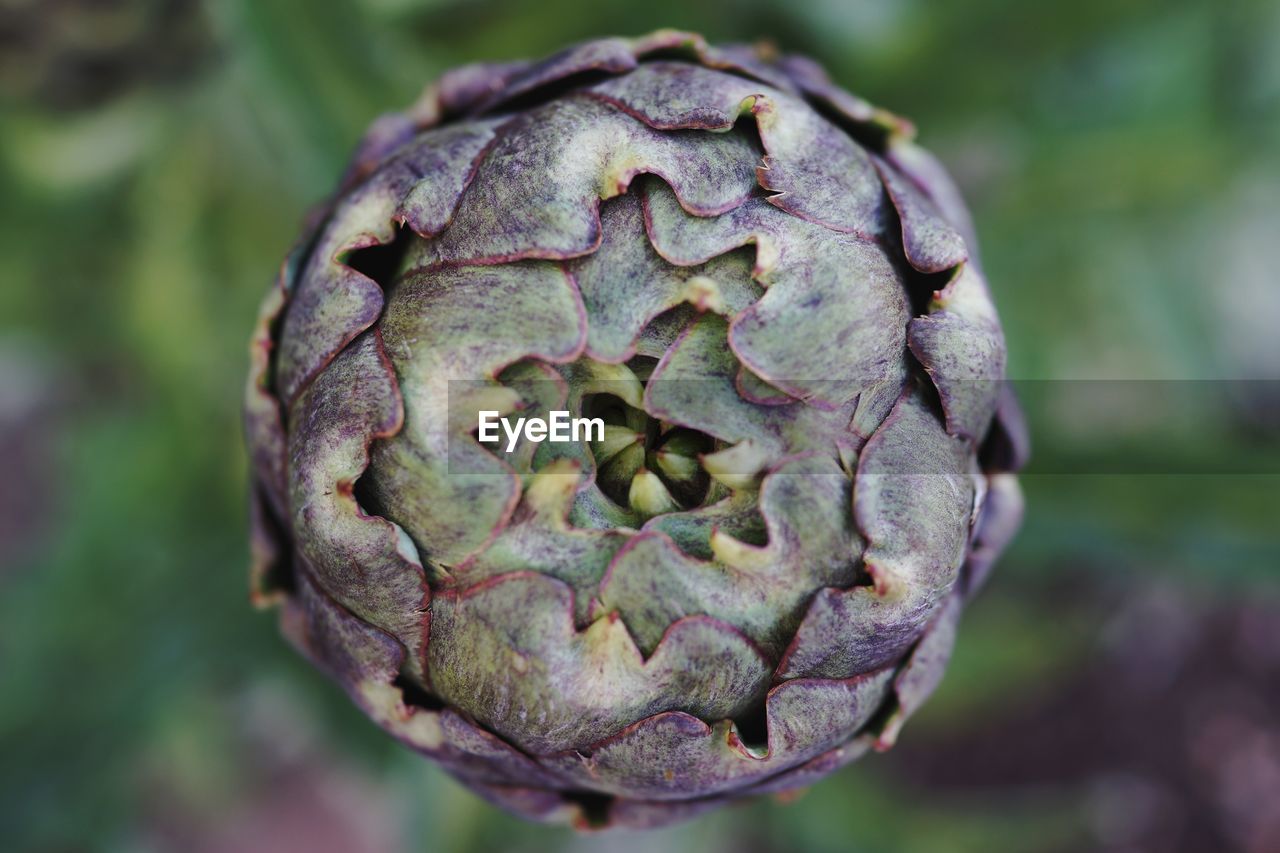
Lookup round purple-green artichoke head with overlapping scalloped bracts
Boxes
[246,31,1025,826]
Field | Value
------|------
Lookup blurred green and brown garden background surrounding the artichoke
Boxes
[0,0,1280,853]
